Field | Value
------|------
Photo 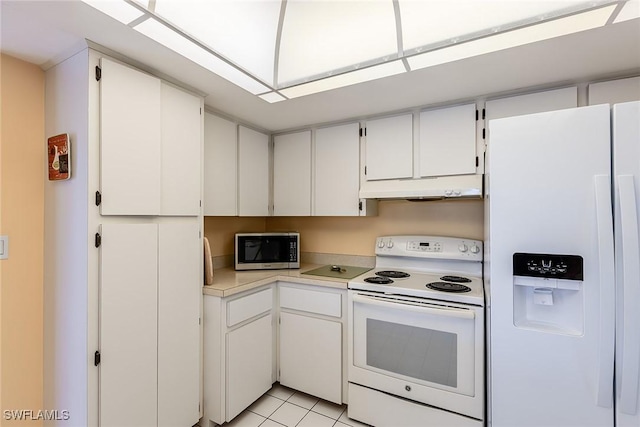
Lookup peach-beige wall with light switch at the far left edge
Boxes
[0,55,45,426]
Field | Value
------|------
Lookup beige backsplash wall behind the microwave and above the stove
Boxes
[205,200,484,256]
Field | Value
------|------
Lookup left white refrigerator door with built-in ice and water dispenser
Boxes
[485,105,615,427]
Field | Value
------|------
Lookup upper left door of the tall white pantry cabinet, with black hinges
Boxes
[100,58,161,215]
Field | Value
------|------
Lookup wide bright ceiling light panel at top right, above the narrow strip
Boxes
[398,0,603,52]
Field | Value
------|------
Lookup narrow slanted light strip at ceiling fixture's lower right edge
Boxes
[407,5,616,70]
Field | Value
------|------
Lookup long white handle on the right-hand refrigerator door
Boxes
[618,175,640,415]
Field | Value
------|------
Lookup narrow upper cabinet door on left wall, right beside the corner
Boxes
[238,126,269,216]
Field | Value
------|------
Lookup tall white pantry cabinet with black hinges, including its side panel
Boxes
[44,49,203,427]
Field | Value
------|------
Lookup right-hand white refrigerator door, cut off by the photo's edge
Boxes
[613,102,640,427]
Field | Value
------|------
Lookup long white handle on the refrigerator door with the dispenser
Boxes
[594,175,615,408]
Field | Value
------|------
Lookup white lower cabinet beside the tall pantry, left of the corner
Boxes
[204,284,276,425]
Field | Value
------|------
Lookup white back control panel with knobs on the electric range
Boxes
[376,236,482,261]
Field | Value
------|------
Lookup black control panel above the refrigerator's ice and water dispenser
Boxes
[513,253,584,280]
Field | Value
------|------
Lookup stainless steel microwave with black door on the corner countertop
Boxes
[235,232,300,270]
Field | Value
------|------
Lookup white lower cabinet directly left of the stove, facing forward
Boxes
[278,282,346,404]
